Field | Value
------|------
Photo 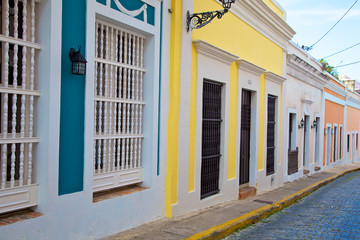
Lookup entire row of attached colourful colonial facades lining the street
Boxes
[0,0,360,239]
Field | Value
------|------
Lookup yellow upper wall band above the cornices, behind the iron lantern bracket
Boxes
[192,0,283,73]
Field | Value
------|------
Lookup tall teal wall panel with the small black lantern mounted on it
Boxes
[59,0,86,195]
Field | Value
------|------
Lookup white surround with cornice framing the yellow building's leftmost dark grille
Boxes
[192,40,238,205]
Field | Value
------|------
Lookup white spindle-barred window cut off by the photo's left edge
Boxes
[0,0,40,213]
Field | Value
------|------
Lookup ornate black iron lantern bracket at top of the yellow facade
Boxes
[186,0,235,31]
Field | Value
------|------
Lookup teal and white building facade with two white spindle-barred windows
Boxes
[0,0,170,239]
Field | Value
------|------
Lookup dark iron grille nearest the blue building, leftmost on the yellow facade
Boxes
[201,81,222,199]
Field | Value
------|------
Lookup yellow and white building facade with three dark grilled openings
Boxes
[166,1,294,217]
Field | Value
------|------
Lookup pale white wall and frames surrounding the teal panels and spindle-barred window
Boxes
[0,0,170,240]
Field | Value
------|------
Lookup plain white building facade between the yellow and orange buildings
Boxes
[284,42,328,181]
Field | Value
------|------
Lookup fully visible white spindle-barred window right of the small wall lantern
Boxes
[94,20,145,191]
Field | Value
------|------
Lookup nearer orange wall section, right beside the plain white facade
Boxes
[323,100,345,166]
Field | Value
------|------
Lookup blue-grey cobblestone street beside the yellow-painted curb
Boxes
[226,172,360,240]
